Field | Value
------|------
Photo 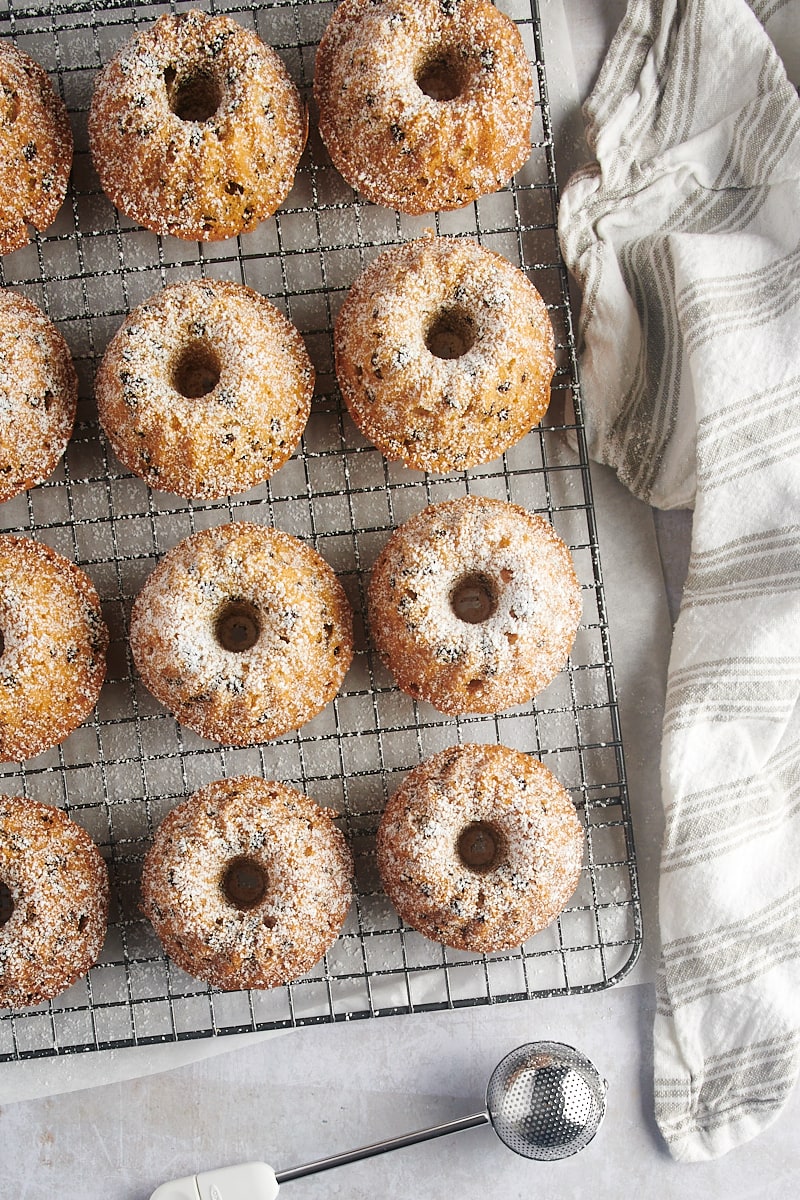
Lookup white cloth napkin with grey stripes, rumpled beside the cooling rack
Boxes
[559,0,800,1160]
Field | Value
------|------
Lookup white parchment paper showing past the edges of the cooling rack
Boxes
[0,0,672,1104]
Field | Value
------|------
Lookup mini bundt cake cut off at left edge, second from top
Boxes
[0,289,78,502]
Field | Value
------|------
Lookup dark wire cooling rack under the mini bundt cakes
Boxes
[0,0,642,1061]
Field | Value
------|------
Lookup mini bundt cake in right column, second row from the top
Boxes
[335,236,555,472]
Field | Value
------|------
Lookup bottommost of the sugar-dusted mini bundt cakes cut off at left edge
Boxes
[0,796,108,1008]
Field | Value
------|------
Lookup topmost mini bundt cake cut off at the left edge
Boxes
[0,41,73,254]
